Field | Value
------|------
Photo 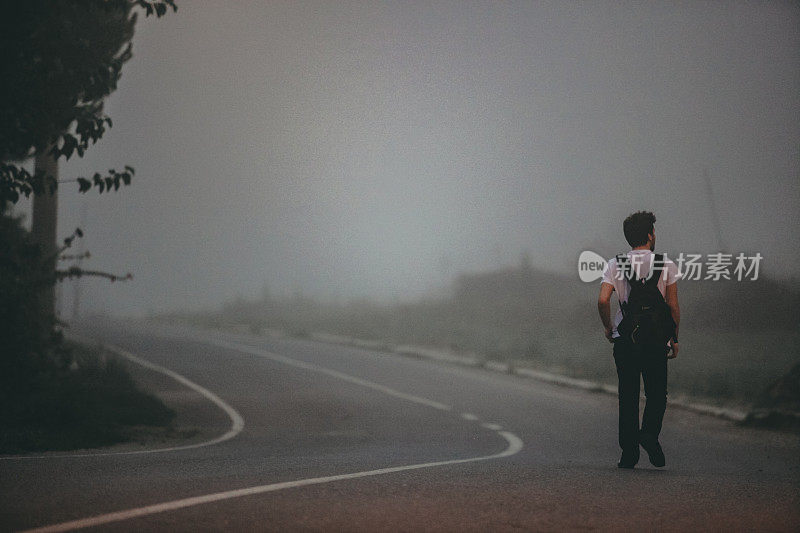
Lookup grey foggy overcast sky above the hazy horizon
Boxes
[18,0,800,314]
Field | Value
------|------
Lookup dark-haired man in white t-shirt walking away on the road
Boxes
[597,211,680,468]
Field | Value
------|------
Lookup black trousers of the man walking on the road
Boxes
[614,340,668,450]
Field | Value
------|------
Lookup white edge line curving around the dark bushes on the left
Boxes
[0,345,244,460]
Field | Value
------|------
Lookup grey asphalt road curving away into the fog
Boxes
[0,325,800,531]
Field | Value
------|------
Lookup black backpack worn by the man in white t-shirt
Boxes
[617,254,675,346]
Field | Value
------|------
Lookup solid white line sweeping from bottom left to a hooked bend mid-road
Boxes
[23,431,523,533]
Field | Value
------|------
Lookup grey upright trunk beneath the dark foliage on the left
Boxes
[31,149,58,318]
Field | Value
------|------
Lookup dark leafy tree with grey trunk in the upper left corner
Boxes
[0,0,177,315]
